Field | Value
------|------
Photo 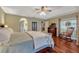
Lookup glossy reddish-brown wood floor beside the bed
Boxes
[39,37,79,53]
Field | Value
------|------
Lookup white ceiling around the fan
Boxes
[1,6,79,19]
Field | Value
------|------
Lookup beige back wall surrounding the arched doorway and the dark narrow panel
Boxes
[5,14,41,32]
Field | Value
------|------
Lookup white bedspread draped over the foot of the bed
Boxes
[27,31,54,49]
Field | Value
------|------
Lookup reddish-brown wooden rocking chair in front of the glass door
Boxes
[61,27,74,41]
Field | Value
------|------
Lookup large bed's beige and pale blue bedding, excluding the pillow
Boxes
[0,27,54,53]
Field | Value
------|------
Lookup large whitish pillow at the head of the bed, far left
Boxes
[0,28,12,43]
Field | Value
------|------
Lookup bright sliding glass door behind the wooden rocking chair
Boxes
[60,18,77,39]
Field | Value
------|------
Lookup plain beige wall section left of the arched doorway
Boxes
[5,14,21,32]
